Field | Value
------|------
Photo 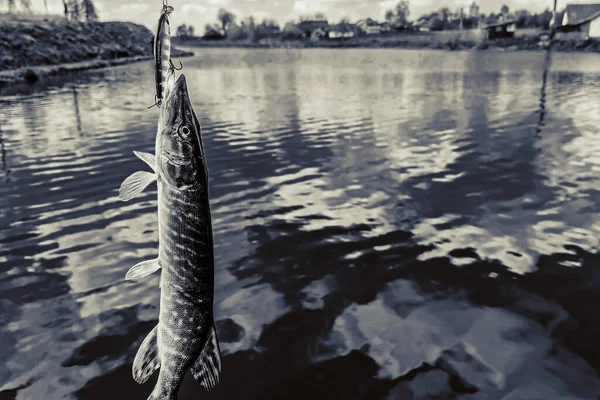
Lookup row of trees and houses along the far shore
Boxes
[176,0,552,41]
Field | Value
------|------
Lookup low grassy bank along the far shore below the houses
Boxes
[174,31,600,52]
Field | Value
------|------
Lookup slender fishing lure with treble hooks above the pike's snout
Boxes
[148,1,183,108]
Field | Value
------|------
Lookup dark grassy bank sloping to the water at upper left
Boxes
[0,15,190,84]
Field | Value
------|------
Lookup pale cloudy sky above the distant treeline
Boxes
[12,0,584,34]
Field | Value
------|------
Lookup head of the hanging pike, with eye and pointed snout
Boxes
[156,74,207,191]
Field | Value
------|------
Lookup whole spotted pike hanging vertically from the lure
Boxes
[119,75,221,400]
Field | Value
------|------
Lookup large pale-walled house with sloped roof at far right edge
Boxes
[556,4,600,39]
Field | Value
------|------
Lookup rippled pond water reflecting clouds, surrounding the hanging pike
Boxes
[0,49,600,400]
